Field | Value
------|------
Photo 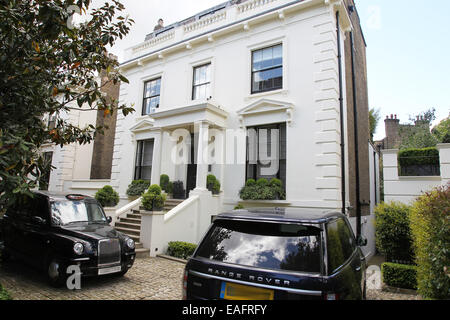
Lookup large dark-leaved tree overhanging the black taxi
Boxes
[0,0,134,209]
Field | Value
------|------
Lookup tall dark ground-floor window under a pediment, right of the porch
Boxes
[246,123,286,186]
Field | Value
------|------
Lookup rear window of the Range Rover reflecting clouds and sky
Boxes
[196,220,321,273]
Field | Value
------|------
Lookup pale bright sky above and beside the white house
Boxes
[89,0,450,140]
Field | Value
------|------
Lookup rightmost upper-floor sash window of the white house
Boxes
[252,44,283,93]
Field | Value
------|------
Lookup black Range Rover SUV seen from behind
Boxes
[183,208,366,300]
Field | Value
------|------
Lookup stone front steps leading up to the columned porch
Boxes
[115,199,184,258]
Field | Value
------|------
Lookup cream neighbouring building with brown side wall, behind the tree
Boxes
[40,54,120,195]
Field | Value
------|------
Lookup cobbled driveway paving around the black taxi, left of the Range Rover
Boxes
[0,258,185,300]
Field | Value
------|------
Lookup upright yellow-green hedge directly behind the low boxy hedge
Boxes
[375,202,414,264]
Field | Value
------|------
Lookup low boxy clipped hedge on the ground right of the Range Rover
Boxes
[381,262,417,290]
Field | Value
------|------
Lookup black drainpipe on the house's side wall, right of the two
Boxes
[350,31,361,239]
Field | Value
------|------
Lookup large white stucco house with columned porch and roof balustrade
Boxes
[110,0,379,255]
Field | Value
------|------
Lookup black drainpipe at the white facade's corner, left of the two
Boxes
[336,11,346,214]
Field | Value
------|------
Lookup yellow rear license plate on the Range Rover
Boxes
[220,282,273,300]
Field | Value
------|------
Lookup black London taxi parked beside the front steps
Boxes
[1,192,136,286]
